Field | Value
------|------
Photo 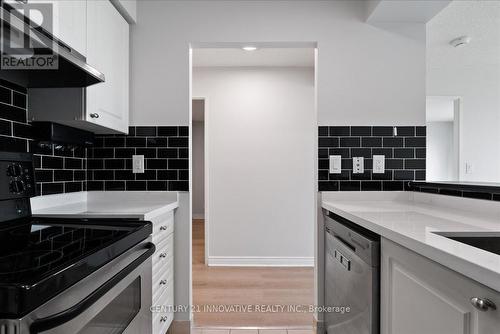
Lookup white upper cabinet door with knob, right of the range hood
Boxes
[86,0,129,133]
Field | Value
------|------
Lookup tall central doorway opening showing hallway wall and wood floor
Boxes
[191,44,317,331]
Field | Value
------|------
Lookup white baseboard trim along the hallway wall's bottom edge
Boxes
[208,256,314,267]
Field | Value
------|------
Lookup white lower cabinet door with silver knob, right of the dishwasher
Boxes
[381,239,500,334]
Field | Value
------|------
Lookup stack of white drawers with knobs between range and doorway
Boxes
[151,211,174,334]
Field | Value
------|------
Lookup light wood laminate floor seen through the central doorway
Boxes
[193,220,314,326]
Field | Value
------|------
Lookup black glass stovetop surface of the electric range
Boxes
[0,218,151,318]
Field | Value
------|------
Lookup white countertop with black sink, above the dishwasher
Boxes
[322,192,500,291]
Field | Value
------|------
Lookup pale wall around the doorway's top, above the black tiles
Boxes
[131,0,425,125]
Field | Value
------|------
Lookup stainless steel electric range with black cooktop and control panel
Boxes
[0,152,155,334]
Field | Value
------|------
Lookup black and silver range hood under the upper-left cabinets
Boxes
[0,0,104,88]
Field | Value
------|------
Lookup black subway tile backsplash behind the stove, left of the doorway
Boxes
[0,80,189,195]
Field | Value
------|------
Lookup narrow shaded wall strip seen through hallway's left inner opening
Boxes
[193,121,205,219]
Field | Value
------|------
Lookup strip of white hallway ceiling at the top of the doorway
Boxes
[193,48,314,67]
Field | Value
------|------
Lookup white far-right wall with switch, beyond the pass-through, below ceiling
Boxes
[427,67,500,182]
